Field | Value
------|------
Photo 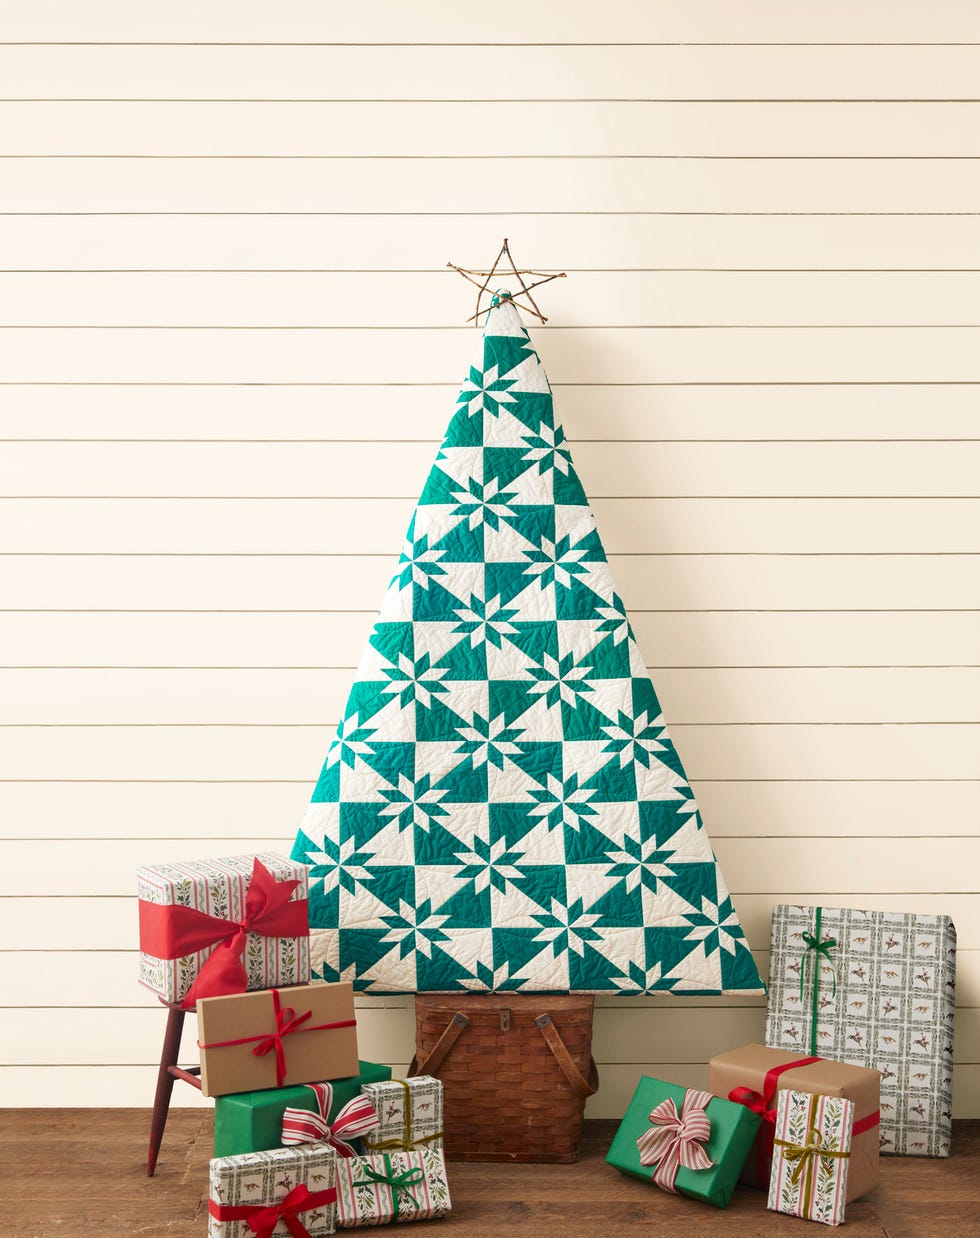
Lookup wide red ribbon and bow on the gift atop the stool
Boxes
[140,859,309,1010]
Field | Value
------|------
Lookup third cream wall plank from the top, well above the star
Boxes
[0,99,980,157]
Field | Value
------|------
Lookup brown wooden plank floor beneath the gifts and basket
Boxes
[0,1109,980,1238]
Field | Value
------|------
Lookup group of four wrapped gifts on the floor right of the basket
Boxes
[608,906,956,1226]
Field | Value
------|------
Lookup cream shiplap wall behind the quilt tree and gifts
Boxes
[0,0,980,1115]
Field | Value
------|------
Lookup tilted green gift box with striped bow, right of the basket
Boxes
[606,1076,761,1208]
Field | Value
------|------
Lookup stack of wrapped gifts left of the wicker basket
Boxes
[139,854,450,1238]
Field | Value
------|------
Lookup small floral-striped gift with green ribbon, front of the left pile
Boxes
[337,1148,453,1229]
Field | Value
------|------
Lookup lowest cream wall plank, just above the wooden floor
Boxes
[7,1059,980,1119]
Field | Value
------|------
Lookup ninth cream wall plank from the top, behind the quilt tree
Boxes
[0,433,980,503]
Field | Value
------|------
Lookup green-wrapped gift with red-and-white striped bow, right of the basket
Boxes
[606,1077,760,1208]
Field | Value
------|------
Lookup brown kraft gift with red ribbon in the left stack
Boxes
[197,982,358,1096]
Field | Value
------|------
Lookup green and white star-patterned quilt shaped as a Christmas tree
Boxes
[293,295,762,994]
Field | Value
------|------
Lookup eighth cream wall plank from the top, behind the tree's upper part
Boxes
[0,386,978,452]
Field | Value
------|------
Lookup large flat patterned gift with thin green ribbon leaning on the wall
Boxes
[766,905,956,1153]
